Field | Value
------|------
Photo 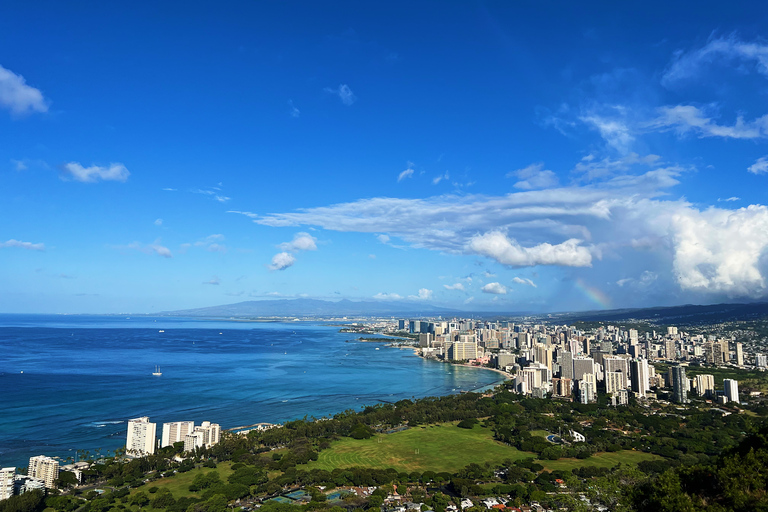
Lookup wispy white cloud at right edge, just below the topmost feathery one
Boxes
[645,105,768,139]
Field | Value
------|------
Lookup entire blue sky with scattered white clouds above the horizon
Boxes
[0,1,768,313]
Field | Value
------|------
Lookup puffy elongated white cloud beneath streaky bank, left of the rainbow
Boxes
[468,231,592,267]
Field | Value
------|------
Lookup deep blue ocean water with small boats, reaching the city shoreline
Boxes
[0,315,499,467]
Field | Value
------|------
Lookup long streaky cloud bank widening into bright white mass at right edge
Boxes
[249,154,768,296]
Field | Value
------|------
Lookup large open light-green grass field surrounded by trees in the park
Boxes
[308,424,535,473]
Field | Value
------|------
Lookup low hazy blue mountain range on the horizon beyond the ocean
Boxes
[160,299,461,318]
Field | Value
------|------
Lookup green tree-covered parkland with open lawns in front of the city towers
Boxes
[6,389,768,512]
